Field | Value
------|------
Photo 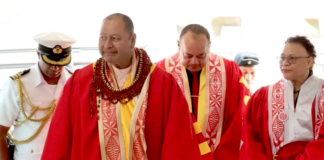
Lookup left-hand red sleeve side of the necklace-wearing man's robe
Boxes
[42,64,101,160]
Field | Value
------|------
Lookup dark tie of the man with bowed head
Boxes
[191,72,199,119]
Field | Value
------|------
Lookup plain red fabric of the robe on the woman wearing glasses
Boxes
[241,86,324,160]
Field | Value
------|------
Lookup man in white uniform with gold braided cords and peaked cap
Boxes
[0,32,76,160]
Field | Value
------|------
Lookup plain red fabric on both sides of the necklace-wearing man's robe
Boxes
[42,64,201,160]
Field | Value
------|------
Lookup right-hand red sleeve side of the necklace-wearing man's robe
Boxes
[145,68,201,160]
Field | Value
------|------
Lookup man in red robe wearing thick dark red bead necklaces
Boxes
[42,13,201,160]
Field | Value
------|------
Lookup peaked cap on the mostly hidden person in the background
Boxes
[234,52,259,67]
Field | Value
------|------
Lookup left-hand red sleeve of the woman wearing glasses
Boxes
[241,87,273,160]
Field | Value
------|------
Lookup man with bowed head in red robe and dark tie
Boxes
[157,24,250,160]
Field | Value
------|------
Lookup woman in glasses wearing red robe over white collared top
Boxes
[241,36,324,160]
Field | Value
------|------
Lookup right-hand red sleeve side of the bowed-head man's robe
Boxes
[214,59,250,160]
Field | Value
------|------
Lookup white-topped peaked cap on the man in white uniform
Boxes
[34,32,77,66]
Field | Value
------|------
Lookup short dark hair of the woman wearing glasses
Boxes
[285,35,316,58]
